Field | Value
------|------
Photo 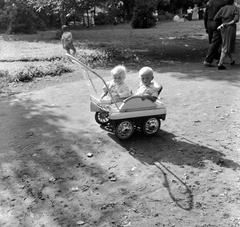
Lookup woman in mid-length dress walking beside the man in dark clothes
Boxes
[214,0,239,70]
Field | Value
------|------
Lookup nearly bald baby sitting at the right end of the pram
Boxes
[134,67,161,102]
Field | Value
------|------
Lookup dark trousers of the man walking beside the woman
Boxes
[205,21,222,63]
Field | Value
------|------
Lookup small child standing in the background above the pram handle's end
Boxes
[61,25,76,57]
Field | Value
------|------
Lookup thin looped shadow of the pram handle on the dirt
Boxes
[154,162,193,210]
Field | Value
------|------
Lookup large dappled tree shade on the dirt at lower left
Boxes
[0,99,133,227]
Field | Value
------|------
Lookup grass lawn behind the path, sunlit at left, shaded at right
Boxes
[0,21,229,86]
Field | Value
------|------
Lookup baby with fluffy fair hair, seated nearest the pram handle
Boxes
[100,65,132,104]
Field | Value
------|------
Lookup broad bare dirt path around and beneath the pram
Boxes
[0,60,240,227]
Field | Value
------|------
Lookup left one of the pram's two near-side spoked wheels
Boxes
[115,120,134,140]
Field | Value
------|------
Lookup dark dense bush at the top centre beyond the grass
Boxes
[132,0,156,28]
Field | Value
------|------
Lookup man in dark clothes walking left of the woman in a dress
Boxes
[203,0,226,66]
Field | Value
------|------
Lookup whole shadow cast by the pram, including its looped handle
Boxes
[108,130,240,210]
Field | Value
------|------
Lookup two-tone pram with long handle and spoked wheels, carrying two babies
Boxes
[67,54,166,140]
